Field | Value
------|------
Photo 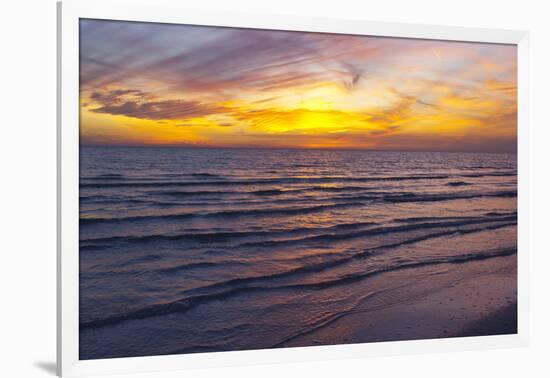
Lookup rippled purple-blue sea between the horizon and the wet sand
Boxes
[80,147,517,359]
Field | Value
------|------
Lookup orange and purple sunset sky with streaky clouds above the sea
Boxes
[80,20,517,152]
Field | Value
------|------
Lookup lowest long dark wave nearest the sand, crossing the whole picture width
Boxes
[80,244,517,329]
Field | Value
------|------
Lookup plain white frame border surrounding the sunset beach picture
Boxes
[57,0,529,376]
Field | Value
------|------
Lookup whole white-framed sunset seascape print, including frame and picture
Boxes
[58,0,528,376]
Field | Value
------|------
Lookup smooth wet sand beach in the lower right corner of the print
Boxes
[281,254,517,346]
